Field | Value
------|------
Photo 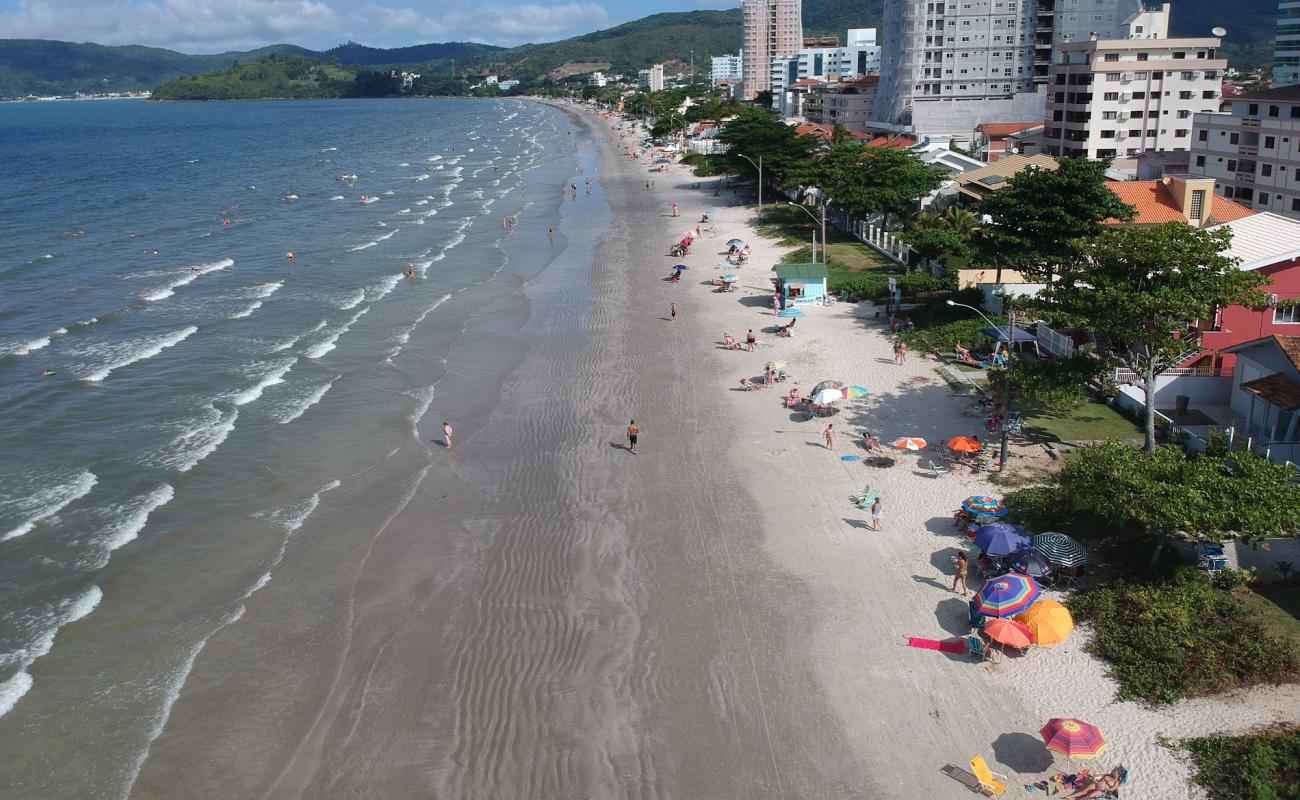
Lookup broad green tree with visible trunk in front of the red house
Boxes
[1048,222,1269,453]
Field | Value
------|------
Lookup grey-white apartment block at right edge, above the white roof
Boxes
[1192,86,1300,219]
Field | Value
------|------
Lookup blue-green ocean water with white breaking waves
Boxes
[0,100,580,797]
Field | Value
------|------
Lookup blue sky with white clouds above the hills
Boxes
[0,0,740,53]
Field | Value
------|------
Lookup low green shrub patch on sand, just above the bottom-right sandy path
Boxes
[1070,567,1296,704]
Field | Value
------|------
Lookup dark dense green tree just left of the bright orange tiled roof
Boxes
[976,159,1134,282]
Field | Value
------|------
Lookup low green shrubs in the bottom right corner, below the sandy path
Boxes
[1179,726,1300,800]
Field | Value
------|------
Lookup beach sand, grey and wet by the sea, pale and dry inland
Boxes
[159,101,1300,800]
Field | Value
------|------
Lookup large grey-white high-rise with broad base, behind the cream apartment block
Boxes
[875,0,1139,138]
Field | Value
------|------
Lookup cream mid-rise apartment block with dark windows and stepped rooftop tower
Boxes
[1043,4,1227,159]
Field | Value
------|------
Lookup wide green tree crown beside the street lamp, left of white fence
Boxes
[787,142,944,228]
